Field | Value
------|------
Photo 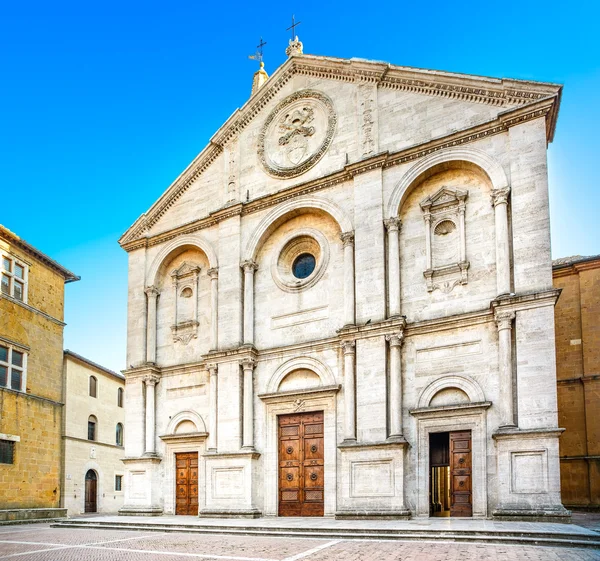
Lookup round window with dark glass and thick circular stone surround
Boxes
[271,228,329,292]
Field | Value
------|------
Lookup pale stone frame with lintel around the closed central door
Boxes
[259,385,340,516]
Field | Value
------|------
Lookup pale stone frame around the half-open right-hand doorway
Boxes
[410,402,491,518]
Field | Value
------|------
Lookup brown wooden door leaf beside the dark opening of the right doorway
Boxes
[450,431,473,516]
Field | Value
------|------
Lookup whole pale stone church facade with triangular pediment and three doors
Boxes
[120,40,569,520]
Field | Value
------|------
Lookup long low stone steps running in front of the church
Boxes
[51,520,600,549]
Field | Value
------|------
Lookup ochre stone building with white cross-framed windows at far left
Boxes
[0,226,79,519]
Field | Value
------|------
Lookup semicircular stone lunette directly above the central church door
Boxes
[266,357,336,394]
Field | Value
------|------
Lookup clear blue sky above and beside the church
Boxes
[0,0,600,370]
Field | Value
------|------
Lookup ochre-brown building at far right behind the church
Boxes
[552,255,600,509]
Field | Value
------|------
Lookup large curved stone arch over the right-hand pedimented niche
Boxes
[386,147,508,218]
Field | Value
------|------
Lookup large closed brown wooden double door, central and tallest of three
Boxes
[279,411,325,516]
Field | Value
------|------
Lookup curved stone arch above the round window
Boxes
[243,196,353,261]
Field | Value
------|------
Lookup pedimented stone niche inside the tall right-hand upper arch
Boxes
[421,187,469,294]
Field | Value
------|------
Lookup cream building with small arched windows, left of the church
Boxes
[62,350,125,516]
